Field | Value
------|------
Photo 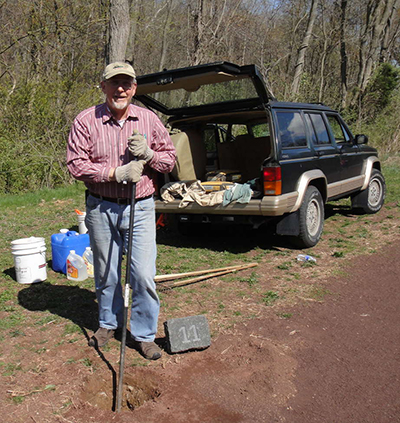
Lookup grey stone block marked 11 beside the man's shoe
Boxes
[164,315,211,353]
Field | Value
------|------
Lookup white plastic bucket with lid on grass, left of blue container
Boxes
[11,236,47,284]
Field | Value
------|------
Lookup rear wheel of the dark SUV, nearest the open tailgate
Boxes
[294,186,325,248]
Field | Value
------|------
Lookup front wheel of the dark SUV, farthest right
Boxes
[351,169,386,214]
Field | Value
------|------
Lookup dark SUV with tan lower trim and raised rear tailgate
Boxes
[135,62,386,248]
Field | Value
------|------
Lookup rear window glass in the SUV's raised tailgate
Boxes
[142,78,258,109]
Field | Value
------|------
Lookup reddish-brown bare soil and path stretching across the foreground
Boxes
[0,207,400,423]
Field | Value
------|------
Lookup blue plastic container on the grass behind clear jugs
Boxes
[51,231,90,274]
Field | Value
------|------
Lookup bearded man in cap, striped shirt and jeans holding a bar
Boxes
[67,62,175,360]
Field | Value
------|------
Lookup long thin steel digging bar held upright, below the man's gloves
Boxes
[117,182,136,413]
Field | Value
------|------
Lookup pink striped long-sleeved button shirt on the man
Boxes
[67,103,175,198]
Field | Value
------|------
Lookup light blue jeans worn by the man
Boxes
[85,195,160,342]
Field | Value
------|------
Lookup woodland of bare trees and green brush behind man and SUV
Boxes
[0,0,400,194]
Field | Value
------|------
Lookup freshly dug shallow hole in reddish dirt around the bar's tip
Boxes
[81,370,160,410]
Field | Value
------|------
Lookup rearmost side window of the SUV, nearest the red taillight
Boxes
[276,112,307,148]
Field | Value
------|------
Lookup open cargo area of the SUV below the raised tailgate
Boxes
[157,111,273,214]
